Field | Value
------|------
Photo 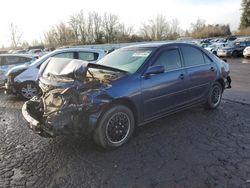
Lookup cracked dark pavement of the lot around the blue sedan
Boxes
[0,59,250,188]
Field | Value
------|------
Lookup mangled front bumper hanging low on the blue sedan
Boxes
[22,100,97,137]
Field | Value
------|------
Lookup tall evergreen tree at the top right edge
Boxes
[239,0,250,29]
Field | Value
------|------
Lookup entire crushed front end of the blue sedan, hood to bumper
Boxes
[22,58,124,137]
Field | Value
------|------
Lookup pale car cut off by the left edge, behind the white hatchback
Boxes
[0,54,36,85]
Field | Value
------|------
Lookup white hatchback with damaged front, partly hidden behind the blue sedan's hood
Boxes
[5,48,106,99]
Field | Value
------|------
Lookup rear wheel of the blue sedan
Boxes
[205,82,223,110]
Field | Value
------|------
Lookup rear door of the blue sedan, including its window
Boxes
[181,45,217,102]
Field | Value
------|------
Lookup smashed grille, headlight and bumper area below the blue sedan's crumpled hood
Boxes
[22,88,93,137]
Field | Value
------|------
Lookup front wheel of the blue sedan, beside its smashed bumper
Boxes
[94,105,135,149]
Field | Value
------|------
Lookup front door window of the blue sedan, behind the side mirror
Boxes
[155,49,181,71]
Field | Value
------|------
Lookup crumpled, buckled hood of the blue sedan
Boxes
[38,58,126,87]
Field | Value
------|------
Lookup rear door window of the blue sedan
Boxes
[181,46,205,67]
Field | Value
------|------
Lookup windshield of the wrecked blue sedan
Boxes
[97,48,153,74]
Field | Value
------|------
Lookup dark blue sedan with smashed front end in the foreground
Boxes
[22,43,231,149]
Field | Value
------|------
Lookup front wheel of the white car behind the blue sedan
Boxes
[18,81,40,100]
